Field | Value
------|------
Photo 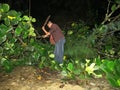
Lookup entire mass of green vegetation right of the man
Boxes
[63,0,120,87]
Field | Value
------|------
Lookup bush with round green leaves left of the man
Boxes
[0,4,41,72]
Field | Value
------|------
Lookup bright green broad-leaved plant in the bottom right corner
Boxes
[100,59,120,87]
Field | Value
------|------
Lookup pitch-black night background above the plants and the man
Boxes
[0,0,108,25]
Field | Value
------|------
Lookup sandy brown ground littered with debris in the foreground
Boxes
[0,66,119,90]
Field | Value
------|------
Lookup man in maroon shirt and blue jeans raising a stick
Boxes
[42,21,65,63]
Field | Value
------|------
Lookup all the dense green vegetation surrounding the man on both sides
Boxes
[0,0,120,87]
